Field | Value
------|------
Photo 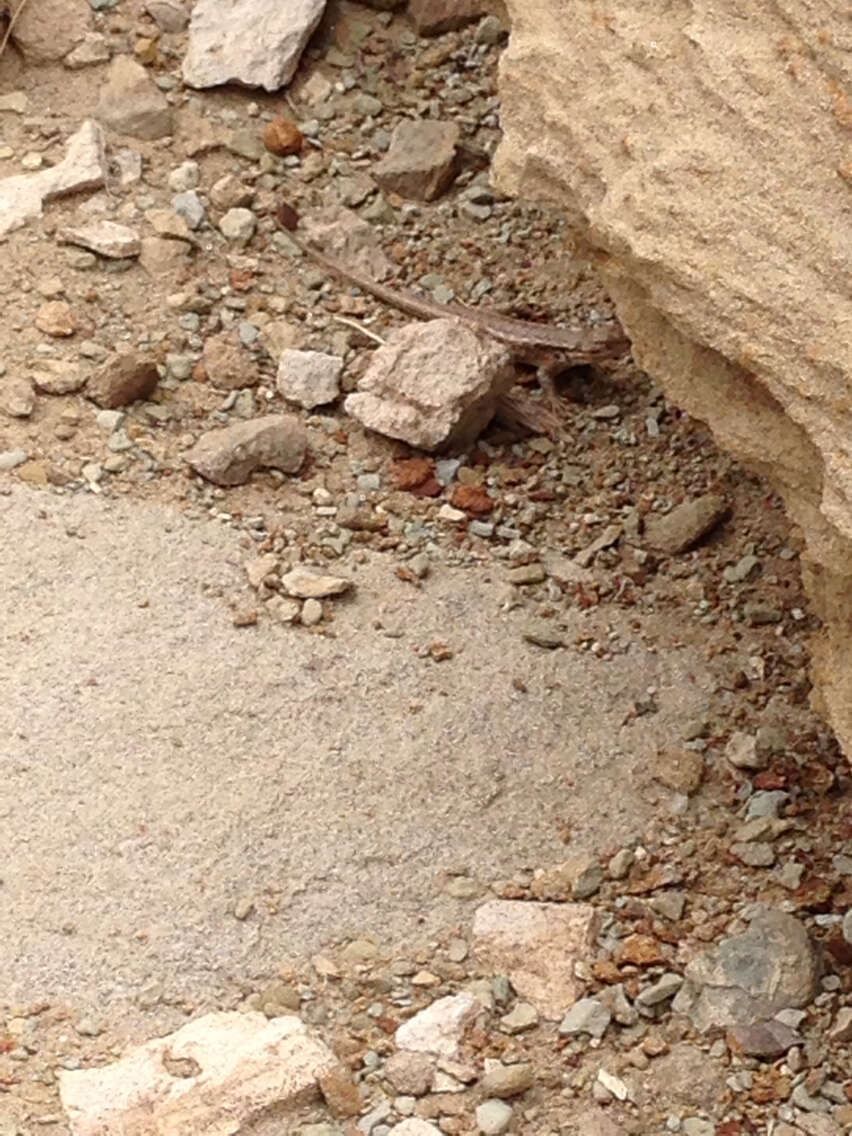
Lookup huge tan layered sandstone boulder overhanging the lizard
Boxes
[495,0,852,753]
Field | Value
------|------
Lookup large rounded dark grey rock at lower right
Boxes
[673,909,820,1031]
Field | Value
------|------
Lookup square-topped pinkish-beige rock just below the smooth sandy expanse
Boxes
[474,900,598,1020]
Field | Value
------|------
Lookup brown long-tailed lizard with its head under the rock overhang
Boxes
[277,206,629,432]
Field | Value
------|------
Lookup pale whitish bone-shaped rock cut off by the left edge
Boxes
[0,119,106,240]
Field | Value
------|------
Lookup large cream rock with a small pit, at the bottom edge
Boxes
[59,1012,337,1136]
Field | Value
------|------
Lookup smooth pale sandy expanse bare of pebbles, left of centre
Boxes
[0,490,710,1014]
